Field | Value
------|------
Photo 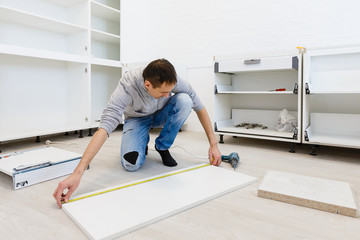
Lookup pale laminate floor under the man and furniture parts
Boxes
[0,130,360,240]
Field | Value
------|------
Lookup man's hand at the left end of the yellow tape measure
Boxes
[53,172,82,208]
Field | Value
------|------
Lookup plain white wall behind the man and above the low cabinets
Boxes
[121,0,360,131]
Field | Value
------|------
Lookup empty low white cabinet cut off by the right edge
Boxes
[303,47,360,154]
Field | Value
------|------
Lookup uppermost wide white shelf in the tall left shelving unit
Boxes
[0,6,87,34]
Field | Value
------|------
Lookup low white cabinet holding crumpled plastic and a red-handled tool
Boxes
[214,50,302,150]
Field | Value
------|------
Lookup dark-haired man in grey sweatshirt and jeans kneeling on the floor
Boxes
[53,59,221,208]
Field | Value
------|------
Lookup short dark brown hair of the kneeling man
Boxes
[143,58,177,88]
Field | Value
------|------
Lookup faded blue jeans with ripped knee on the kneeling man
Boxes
[121,93,192,171]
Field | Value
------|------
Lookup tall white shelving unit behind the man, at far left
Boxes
[0,0,122,146]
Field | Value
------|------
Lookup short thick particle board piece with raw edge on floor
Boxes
[258,171,357,217]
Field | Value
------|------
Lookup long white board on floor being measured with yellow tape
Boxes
[62,166,256,239]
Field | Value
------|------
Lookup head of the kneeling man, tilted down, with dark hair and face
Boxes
[143,58,177,98]
